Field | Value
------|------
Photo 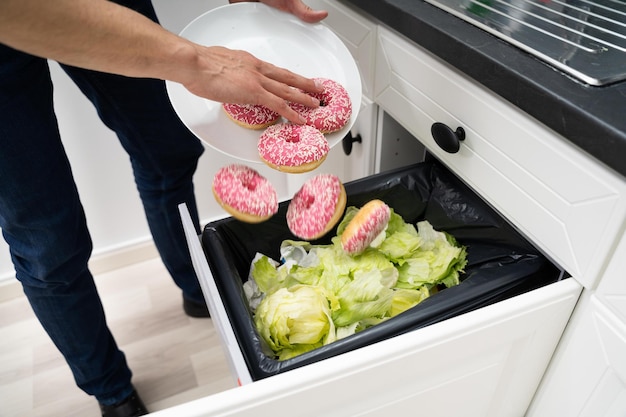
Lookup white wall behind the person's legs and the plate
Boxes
[0,0,280,283]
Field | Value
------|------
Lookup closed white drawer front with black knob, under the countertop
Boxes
[374,27,626,288]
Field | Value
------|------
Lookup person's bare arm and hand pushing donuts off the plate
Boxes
[0,0,319,123]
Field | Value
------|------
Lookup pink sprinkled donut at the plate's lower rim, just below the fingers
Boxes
[258,123,330,173]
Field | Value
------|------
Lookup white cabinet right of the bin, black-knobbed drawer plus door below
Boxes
[374,28,626,417]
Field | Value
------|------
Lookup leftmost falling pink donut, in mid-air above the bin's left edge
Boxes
[212,164,278,223]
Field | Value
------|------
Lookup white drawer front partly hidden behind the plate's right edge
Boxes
[306,0,376,98]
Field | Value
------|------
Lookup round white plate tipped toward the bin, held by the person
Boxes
[166,2,361,163]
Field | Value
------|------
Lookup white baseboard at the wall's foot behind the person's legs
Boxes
[0,240,159,303]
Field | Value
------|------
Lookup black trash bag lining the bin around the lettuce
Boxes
[202,161,562,380]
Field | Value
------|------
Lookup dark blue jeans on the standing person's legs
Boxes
[0,0,204,404]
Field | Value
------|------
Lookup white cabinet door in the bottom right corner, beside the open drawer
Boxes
[528,232,626,417]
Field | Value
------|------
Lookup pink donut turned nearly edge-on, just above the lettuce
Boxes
[341,200,391,255]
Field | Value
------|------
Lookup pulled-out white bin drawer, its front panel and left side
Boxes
[165,207,581,417]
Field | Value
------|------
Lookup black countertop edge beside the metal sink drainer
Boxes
[340,0,626,177]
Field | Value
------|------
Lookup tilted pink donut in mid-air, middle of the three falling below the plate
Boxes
[287,174,346,240]
